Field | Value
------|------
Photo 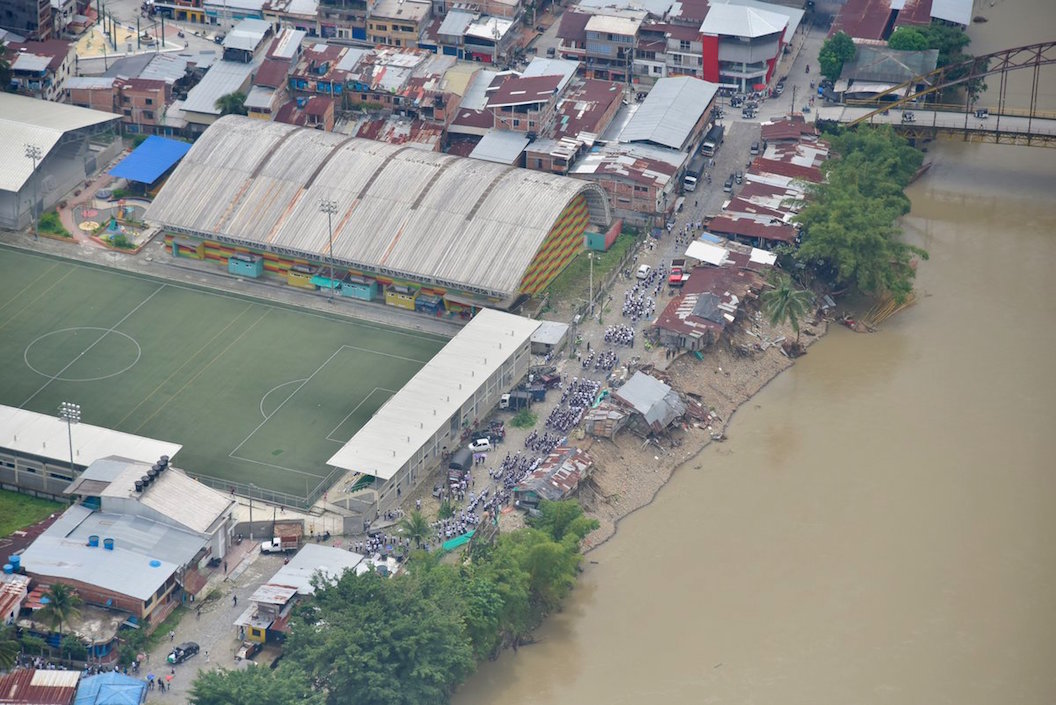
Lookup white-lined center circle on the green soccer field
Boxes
[22,326,143,382]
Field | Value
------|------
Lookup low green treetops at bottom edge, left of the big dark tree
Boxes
[190,664,326,705]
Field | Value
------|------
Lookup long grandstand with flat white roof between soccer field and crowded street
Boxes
[327,308,540,530]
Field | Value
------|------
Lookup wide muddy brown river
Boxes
[455,2,1056,705]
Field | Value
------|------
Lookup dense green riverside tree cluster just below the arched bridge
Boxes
[792,126,927,302]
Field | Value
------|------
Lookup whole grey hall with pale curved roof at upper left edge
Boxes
[0,93,120,230]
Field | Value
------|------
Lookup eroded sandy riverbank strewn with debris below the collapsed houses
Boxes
[580,321,829,552]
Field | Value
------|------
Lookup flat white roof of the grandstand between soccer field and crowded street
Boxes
[326,308,539,480]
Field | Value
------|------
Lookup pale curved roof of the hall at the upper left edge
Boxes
[0,93,121,192]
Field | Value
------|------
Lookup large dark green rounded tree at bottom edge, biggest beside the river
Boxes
[286,572,473,705]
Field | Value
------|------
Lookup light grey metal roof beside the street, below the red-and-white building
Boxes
[620,76,719,150]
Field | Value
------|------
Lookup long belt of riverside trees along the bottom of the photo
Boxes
[191,500,598,705]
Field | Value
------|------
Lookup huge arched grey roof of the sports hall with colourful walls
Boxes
[146,115,609,299]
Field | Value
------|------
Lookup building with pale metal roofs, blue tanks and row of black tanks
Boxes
[21,456,235,622]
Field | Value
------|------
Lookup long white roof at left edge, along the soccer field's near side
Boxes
[0,401,183,465]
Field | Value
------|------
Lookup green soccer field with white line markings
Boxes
[0,248,446,497]
